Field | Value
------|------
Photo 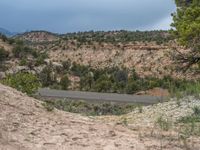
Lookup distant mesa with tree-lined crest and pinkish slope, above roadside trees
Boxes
[13,31,198,79]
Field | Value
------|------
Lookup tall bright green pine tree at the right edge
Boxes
[172,0,200,69]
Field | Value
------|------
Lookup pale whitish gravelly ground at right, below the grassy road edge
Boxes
[122,96,200,127]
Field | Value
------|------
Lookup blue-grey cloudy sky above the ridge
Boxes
[0,0,176,33]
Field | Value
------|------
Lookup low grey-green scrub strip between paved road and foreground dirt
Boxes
[44,99,138,116]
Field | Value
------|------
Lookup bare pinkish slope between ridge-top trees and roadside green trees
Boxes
[42,40,199,79]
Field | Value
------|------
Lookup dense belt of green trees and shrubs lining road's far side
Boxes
[39,60,200,98]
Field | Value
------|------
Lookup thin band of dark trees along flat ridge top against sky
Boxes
[63,30,173,44]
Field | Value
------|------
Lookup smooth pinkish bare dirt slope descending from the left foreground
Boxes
[0,85,143,150]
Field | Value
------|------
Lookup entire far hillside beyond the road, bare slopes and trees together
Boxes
[0,31,200,94]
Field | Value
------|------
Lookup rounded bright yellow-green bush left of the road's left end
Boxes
[2,73,41,94]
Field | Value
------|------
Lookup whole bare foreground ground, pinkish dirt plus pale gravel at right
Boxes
[0,85,200,150]
